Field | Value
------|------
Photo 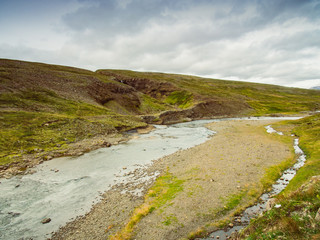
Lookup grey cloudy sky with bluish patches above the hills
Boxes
[0,0,320,88]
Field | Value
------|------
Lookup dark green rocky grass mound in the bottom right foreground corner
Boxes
[241,181,320,240]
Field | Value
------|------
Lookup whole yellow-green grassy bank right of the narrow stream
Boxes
[243,114,320,239]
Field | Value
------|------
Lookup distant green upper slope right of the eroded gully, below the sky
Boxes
[98,70,320,115]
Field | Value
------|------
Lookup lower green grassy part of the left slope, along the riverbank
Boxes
[0,111,144,165]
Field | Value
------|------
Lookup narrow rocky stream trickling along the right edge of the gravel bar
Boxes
[198,125,306,240]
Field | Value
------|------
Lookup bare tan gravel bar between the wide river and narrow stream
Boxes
[53,120,291,240]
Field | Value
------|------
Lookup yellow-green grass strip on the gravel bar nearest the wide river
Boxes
[110,171,184,240]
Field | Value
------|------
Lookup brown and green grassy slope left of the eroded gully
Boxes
[0,61,145,165]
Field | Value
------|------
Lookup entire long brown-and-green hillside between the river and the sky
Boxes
[0,59,320,171]
